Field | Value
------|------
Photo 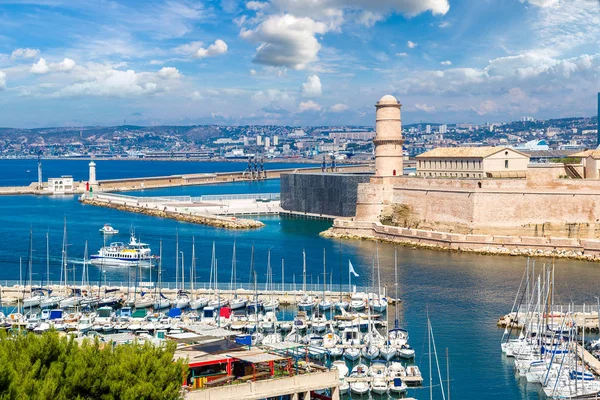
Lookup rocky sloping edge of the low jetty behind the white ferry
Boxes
[79,197,265,229]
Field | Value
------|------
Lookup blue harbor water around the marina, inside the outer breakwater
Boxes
[0,159,600,400]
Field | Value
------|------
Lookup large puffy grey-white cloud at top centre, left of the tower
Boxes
[240,14,327,69]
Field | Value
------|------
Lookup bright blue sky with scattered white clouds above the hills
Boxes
[0,0,600,128]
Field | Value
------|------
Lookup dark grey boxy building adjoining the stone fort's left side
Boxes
[281,173,371,217]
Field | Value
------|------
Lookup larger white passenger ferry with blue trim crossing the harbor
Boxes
[91,233,155,268]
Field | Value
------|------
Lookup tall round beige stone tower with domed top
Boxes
[373,94,404,177]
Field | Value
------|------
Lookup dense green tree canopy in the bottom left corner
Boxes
[0,331,187,400]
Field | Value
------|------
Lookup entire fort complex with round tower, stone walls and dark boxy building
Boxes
[281,95,600,244]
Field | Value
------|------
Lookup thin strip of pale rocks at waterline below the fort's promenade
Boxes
[320,227,600,262]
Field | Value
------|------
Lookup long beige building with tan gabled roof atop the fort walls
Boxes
[416,147,529,178]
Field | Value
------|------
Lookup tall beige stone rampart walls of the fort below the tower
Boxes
[355,168,600,239]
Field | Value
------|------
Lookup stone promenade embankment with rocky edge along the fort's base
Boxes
[321,219,600,262]
